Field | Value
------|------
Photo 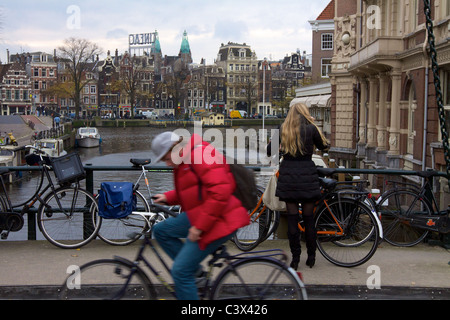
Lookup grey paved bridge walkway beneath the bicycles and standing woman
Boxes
[0,240,450,299]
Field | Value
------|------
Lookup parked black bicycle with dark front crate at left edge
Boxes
[0,146,100,249]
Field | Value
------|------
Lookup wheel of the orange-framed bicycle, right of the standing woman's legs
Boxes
[316,198,380,267]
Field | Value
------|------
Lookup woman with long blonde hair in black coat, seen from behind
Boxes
[276,103,328,269]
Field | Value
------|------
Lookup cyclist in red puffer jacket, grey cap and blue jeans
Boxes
[151,132,249,300]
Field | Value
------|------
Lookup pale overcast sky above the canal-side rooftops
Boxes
[0,0,330,64]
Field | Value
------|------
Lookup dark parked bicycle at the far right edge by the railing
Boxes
[377,170,450,247]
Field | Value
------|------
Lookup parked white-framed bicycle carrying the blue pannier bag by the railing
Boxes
[98,159,180,246]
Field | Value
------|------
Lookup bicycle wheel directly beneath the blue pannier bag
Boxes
[98,191,150,246]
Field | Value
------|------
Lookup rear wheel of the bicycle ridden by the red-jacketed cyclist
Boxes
[211,257,307,300]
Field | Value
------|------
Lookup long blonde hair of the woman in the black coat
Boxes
[280,103,328,157]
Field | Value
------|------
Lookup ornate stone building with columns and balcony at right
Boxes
[330,0,450,205]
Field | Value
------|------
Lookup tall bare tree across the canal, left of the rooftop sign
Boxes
[58,38,101,119]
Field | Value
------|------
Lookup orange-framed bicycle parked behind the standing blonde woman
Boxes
[235,168,383,267]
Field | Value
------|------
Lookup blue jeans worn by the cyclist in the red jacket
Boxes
[153,212,233,300]
